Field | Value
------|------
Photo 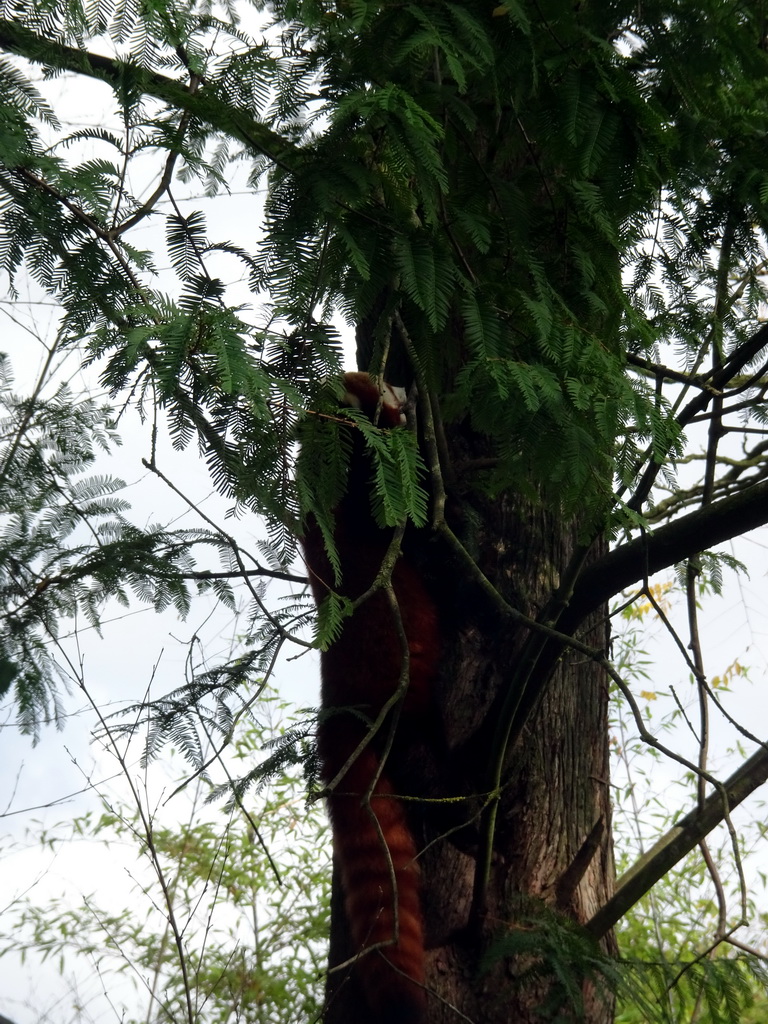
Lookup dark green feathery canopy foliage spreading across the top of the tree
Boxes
[0,0,768,536]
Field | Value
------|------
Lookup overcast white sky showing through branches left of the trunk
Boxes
[0,59,327,1024]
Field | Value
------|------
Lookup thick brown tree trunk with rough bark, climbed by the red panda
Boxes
[325,466,613,1024]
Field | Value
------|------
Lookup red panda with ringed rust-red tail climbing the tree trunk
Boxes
[303,373,439,1024]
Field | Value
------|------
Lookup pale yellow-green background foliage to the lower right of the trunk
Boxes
[611,593,768,1024]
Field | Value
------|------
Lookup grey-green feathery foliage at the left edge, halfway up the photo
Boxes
[0,357,231,739]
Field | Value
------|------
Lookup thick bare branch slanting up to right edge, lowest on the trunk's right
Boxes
[586,746,768,938]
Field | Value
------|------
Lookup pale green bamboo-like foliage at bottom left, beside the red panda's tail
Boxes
[0,703,329,1024]
